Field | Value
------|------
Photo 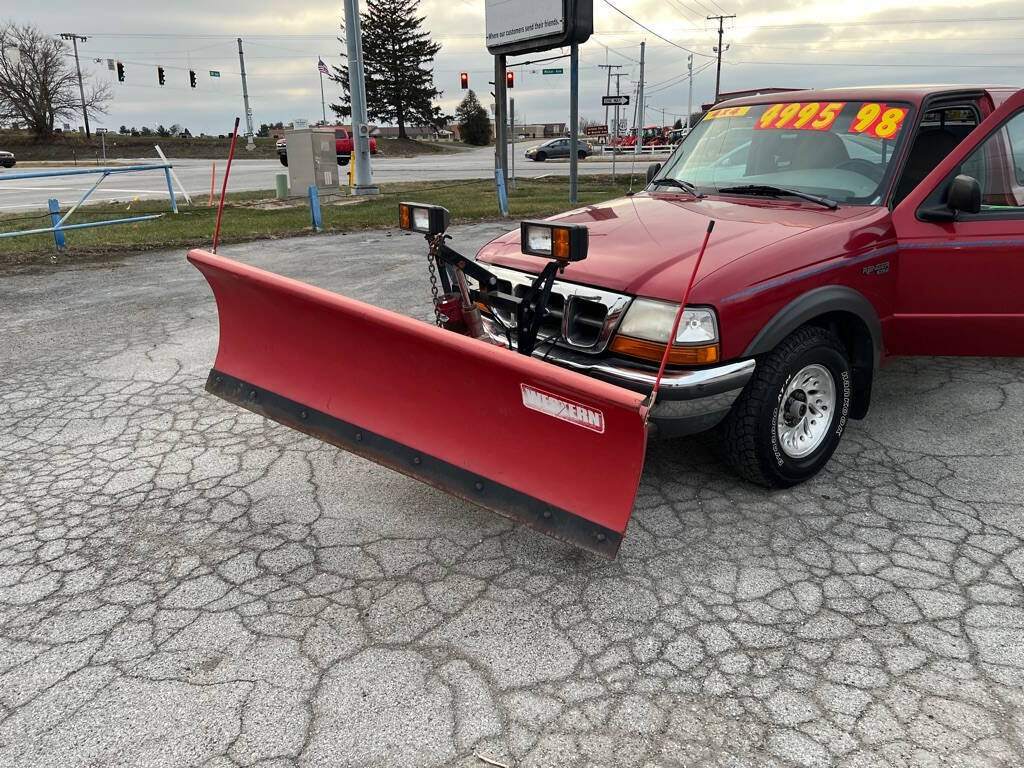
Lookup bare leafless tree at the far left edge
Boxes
[0,24,113,136]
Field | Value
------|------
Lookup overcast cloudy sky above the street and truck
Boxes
[8,0,1024,133]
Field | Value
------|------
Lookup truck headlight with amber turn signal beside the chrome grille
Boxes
[610,299,721,366]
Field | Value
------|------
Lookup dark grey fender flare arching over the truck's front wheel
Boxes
[744,286,883,419]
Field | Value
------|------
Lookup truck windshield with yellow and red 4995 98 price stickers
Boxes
[657,101,910,205]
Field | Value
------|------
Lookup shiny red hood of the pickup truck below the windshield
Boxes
[477,193,872,301]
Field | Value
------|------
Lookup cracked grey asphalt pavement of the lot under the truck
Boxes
[0,219,1024,768]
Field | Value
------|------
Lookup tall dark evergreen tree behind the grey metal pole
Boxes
[331,0,445,138]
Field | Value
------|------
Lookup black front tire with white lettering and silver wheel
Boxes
[721,327,853,488]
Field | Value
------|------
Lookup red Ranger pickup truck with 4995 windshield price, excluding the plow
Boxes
[477,86,1024,486]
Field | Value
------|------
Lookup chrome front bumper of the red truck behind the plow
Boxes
[483,317,756,437]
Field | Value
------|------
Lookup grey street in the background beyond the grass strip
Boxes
[0,141,664,213]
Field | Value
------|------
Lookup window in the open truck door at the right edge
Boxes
[959,112,1024,214]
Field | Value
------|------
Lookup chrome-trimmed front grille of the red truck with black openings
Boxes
[486,264,630,354]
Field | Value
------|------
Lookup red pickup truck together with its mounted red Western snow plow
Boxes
[189,86,1024,557]
